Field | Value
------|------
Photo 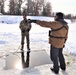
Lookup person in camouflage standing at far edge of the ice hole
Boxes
[19,13,31,50]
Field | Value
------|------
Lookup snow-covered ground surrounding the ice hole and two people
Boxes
[0,15,76,75]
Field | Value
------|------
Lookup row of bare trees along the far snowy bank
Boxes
[0,0,76,19]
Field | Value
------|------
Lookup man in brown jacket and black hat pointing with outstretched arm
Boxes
[29,12,69,74]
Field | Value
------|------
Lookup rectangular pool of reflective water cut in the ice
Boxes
[4,51,52,70]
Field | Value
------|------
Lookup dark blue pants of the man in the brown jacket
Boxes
[50,45,66,71]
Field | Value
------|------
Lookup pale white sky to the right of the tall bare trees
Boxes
[47,0,76,15]
